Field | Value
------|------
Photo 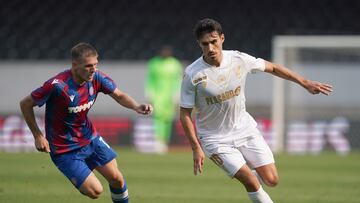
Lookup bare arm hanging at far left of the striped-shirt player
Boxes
[20,95,50,152]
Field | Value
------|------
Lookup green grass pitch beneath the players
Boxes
[0,149,360,203]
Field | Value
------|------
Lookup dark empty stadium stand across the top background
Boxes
[0,0,360,60]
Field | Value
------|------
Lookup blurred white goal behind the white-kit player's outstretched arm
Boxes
[272,36,360,154]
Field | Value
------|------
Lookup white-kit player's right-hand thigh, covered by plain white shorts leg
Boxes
[237,136,275,169]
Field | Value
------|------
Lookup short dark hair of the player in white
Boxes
[194,18,223,39]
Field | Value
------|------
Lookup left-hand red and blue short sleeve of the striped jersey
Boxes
[31,79,59,107]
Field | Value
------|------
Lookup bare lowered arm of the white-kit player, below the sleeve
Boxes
[180,107,205,175]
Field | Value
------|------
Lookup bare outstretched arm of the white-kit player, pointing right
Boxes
[265,61,332,95]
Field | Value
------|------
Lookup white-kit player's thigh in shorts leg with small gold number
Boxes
[204,146,246,178]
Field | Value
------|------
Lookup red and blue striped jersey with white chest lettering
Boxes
[31,70,116,154]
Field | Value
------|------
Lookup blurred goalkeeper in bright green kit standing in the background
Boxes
[145,46,182,153]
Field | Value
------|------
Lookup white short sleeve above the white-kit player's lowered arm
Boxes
[180,73,195,108]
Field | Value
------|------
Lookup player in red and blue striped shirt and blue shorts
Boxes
[20,43,152,203]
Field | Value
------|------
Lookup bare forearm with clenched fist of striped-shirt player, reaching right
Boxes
[110,88,153,115]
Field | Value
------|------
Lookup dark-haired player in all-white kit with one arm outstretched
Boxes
[180,19,332,203]
